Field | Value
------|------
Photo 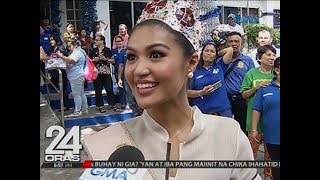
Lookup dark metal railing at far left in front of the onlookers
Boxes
[40,69,65,127]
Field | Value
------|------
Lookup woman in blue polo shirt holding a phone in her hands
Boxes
[188,41,233,117]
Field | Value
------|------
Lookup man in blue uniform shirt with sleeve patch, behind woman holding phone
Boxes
[225,31,254,134]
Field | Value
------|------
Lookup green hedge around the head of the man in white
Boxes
[244,24,280,48]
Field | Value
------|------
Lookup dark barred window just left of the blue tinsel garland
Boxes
[66,0,83,30]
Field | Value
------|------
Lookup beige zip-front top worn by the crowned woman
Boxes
[83,107,261,180]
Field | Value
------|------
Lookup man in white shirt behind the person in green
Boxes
[248,30,280,67]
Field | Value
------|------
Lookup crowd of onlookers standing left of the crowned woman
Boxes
[40,18,142,118]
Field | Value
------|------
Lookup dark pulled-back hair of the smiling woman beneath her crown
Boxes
[129,19,195,58]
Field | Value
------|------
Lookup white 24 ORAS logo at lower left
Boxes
[44,126,82,162]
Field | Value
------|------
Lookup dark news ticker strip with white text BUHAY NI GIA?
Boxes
[41,161,280,168]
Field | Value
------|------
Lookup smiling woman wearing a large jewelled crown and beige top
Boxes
[84,0,261,180]
